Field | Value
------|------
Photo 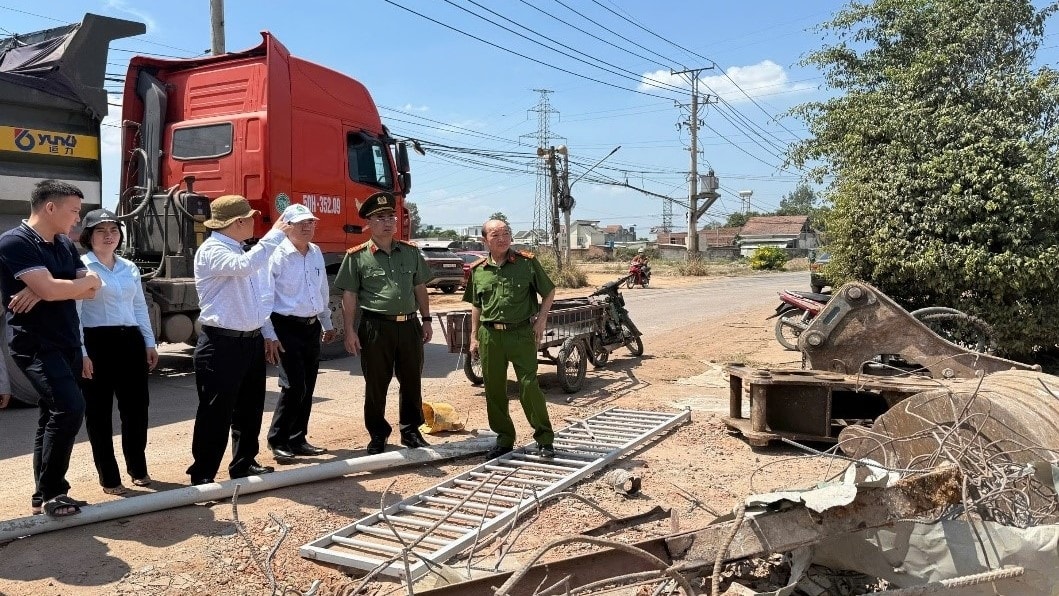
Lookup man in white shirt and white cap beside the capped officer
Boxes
[263,203,335,462]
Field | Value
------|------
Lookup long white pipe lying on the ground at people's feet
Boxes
[0,431,497,543]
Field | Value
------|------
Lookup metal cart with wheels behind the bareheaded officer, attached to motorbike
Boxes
[442,299,606,393]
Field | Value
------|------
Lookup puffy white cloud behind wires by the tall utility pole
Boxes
[640,60,812,104]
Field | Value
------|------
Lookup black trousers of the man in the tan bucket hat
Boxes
[187,327,265,482]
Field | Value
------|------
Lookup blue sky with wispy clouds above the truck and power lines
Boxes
[0,0,1054,236]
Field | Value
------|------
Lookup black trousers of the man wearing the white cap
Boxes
[268,312,321,447]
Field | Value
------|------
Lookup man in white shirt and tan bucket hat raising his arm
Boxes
[187,195,290,484]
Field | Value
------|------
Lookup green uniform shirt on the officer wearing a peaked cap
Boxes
[335,240,430,314]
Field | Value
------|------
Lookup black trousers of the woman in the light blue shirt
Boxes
[80,327,150,487]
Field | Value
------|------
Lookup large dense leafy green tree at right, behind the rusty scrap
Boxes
[790,0,1059,357]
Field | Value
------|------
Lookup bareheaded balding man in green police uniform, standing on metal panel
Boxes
[463,219,555,459]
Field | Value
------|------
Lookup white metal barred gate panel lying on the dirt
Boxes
[300,408,690,580]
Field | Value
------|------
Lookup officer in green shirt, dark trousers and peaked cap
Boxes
[335,193,432,455]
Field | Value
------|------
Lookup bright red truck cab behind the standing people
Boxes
[122,32,410,260]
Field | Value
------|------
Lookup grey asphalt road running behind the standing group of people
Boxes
[0,272,808,486]
